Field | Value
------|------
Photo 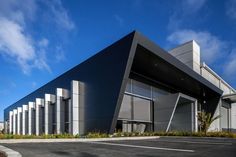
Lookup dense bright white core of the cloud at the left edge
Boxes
[0,17,36,73]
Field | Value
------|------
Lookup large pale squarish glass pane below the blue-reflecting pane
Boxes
[133,97,151,121]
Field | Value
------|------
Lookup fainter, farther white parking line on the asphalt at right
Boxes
[157,140,232,145]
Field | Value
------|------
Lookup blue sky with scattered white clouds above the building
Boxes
[0,0,236,120]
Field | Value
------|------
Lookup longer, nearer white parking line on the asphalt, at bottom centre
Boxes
[87,142,194,153]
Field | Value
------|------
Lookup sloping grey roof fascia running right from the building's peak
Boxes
[133,31,223,95]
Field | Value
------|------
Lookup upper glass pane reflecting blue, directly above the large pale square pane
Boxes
[132,80,151,98]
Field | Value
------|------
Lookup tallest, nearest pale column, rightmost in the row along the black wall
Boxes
[71,80,84,135]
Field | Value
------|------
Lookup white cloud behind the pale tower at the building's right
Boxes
[167,30,227,64]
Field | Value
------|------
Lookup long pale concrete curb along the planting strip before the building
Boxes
[0,136,160,143]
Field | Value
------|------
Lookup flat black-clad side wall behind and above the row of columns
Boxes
[4,33,134,131]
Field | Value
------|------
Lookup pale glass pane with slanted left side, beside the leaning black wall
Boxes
[119,95,131,119]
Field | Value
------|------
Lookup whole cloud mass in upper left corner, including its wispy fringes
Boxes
[0,0,50,74]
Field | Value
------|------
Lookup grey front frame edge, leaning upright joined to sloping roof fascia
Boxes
[109,31,223,133]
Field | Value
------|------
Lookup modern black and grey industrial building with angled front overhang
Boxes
[4,31,236,135]
